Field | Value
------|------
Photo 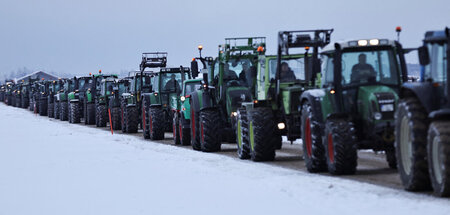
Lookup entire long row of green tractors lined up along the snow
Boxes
[0,28,450,196]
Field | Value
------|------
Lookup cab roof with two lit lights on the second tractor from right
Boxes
[322,39,395,54]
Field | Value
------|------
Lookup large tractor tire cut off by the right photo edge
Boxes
[427,121,450,197]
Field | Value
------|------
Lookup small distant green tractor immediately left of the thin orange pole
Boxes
[95,77,120,127]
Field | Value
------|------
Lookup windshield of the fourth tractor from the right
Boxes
[223,58,256,86]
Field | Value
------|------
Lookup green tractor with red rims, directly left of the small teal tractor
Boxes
[142,66,191,143]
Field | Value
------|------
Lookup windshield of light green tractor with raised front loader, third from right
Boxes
[269,58,305,82]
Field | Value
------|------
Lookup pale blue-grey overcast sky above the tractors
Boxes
[0,0,450,77]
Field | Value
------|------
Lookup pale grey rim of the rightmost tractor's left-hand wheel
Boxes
[400,116,413,175]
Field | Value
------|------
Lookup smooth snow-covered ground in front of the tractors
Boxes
[0,104,450,215]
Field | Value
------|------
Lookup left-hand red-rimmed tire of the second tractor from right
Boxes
[301,102,328,172]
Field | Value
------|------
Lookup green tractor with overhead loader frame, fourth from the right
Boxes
[190,37,266,152]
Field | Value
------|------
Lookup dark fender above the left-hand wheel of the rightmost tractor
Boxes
[399,82,439,113]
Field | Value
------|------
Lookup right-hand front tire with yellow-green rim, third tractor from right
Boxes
[247,107,280,161]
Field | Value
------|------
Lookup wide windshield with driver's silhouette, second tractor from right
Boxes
[342,50,400,86]
